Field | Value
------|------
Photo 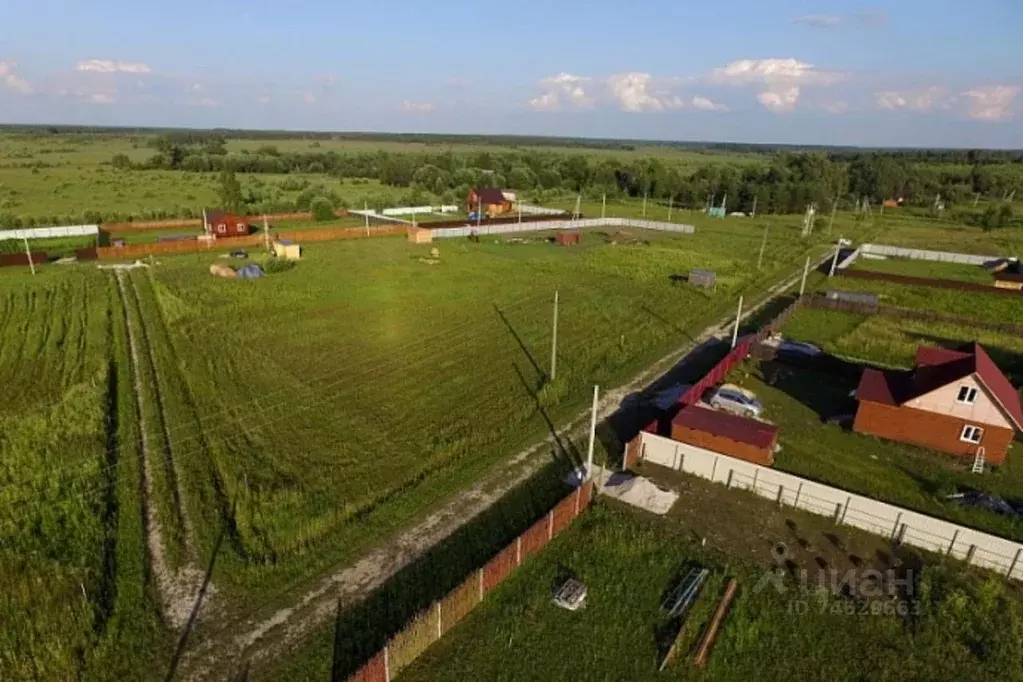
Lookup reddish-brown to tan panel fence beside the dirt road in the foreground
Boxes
[348,481,593,682]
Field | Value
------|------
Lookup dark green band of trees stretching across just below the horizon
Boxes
[113,131,1023,213]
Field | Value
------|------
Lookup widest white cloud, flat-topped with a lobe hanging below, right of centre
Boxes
[708,57,842,113]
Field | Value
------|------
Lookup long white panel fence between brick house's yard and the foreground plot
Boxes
[640,433,1023,580]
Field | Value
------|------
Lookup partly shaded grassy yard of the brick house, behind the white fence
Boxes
[720,363,1023,538]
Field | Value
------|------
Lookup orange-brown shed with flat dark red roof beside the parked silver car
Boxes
[671,405,779,466]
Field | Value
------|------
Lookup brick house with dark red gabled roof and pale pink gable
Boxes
[853,344,1023,464]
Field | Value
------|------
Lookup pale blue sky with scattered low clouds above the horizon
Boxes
[0,0,1023,148]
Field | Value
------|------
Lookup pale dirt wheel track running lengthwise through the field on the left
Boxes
[115,270,213,630]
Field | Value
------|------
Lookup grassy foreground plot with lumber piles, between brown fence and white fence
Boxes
[298,501,1023,682]
